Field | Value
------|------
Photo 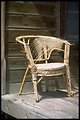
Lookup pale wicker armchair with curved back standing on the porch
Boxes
[16,35,72,102]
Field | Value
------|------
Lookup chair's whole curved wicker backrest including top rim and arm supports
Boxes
[16,35,69,64]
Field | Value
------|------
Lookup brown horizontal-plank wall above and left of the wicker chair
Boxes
[5,1,60,88]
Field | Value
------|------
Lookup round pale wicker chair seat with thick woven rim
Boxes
[36,63,65,76]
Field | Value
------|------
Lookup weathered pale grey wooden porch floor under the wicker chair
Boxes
[2,92,79,119]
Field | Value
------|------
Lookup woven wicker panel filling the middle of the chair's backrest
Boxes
[32,37,64,59]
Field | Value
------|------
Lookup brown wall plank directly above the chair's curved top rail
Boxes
[7,28,58,42]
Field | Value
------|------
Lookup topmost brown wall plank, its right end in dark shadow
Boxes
[8,2,58,15]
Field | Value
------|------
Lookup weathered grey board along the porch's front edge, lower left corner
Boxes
[2,95,47,119]
